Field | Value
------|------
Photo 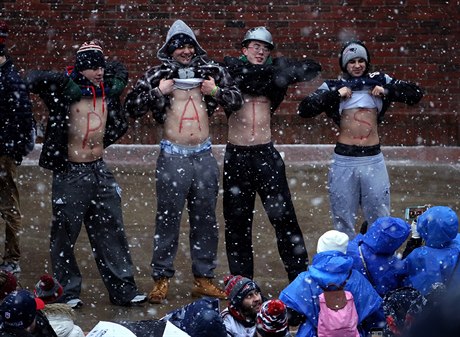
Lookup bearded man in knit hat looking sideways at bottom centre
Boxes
[221,275,263,337]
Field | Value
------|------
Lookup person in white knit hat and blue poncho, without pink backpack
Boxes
[279,230,384,337]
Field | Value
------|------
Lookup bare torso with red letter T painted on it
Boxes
[228,96,271,146]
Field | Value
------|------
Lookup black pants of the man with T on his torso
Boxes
[223,143,308,281]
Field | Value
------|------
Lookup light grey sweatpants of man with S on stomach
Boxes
[328,153,390,240]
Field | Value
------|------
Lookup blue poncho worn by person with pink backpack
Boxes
[279,251,382,337]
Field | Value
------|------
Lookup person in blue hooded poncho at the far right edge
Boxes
[405,206,460,296]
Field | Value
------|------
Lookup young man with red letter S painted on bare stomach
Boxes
[299,41,423,239]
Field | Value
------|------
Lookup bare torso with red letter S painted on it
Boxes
[338,108,380,146]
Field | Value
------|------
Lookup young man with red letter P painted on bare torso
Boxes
[27,40,146,307]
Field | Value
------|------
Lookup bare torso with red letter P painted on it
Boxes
[68,97,107,163]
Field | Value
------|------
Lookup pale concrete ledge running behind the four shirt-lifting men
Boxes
[23,144,460,167]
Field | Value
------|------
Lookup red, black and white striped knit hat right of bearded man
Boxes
[256,299,289,337]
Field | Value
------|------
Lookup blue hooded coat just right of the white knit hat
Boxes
[347,217,410,296]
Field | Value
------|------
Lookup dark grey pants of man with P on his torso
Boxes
[50,160,137,305]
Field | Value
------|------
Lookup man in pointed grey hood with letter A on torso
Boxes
[125,20,243,304]
